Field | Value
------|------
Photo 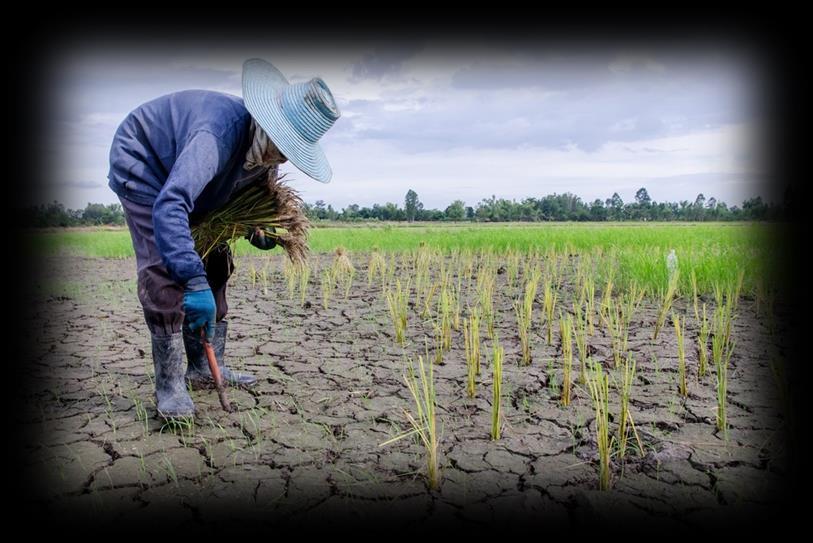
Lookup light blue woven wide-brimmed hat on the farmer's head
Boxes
[243,58,341,183]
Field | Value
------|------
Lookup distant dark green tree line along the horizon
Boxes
[22,188,788,227]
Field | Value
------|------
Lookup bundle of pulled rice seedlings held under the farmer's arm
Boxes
[192,174,310,264]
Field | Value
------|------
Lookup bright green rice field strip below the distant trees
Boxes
[28,223,784,294]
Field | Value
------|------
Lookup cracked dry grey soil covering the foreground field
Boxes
[19,254,787,531]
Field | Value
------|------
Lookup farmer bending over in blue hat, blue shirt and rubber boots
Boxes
[108,59,339,418]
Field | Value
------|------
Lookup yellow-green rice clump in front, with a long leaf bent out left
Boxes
[380,355,440,490]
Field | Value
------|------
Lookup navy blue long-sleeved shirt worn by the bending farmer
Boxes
[108,90,267,290]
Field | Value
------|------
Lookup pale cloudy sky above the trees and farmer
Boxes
[41,41,769,209]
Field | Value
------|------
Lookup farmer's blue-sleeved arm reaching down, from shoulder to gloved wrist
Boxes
[153,131,229,291]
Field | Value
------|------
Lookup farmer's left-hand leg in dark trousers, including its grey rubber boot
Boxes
[120,198,195,418]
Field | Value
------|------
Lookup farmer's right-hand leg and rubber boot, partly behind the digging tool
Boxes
[184,245,257,388]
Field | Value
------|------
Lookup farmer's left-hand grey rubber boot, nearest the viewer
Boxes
[152,333,195,419]
